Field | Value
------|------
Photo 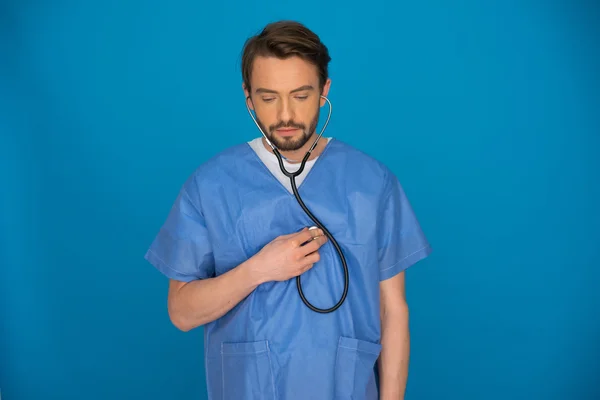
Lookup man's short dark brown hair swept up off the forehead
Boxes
[242,21,331,92]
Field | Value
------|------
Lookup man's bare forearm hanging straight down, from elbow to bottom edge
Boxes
[378,306,410,400]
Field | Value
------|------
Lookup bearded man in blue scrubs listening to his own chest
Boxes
[146,21,431,400]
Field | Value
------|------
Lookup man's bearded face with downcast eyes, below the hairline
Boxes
[245,57,330,151]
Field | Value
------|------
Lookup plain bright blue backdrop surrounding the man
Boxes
[0,0,600,400]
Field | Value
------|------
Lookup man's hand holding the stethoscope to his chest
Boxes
[250,228,327,283]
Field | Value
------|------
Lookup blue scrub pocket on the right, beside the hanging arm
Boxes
[335,336,381,400]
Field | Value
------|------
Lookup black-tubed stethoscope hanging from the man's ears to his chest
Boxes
[246,95,349,313]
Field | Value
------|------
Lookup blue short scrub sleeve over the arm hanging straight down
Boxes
[377,171,431,281]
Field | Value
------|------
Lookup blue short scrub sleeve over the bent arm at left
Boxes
[144,179,215,282]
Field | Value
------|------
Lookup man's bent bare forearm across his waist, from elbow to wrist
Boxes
[169,260,260,331]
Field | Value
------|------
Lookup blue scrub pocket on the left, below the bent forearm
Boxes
[221,340,276,400]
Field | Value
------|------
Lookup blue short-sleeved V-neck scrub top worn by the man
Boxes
[145,139,431,400]
